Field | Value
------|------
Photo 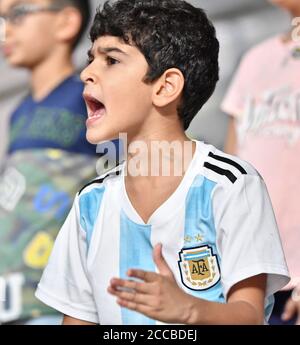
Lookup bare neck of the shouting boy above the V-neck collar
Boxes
[125,120,196,224]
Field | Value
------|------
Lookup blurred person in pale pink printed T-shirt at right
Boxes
[222,0,300,324]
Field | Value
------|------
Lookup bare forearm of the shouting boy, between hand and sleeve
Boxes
[185,296,264,325]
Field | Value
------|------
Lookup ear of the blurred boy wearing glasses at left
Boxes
[55,7,82,42]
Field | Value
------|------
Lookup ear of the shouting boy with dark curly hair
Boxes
[152,68,185,107]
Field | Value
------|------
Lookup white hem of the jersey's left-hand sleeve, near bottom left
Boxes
[35,285,99,324]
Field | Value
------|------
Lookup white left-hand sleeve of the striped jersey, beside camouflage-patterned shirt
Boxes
[35,198,99,323]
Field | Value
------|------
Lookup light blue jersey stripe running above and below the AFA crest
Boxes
[184,175,225,303]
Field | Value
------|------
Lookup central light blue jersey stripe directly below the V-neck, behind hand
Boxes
[120,211,155,325]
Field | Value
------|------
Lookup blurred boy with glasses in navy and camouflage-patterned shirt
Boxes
[0,0,96,324]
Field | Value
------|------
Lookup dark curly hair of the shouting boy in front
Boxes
[90,0,219,130]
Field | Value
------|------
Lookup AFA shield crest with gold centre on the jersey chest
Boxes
[178,246,220,291]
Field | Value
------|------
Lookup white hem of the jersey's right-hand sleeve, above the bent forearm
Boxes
[222,263,290,300]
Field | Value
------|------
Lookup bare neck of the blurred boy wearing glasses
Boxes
[31,49,75,101]
